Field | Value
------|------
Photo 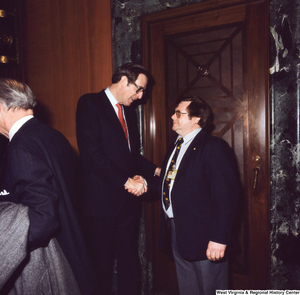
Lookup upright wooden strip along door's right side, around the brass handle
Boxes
[247,1,270,289]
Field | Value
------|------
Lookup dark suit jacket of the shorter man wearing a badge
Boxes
[161,130,239,260]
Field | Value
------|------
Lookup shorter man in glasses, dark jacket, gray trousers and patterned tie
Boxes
[161,97,239,295]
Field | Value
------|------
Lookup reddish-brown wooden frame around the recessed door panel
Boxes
[142,0,270,289]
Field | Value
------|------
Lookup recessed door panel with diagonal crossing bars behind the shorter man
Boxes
[165,22,248,273]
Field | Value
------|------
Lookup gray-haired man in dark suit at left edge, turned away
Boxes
[0,79,96,295]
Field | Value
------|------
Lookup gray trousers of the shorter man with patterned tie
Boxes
[171,219,228,295]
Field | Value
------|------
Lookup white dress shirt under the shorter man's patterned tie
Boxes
[162,127,201,218]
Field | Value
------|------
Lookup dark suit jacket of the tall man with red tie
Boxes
[76,90,156,217]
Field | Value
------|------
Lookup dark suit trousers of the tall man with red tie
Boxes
[85,202,141,295]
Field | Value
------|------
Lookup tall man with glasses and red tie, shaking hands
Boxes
[76,63,160,295]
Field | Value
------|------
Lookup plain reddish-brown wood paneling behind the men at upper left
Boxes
[27,0,112,149]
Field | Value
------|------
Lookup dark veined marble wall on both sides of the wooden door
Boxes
[112,0,300,294]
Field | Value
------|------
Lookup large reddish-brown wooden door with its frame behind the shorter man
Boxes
[142,0,270,295]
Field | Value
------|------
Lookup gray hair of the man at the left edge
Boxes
[0,79,37,110]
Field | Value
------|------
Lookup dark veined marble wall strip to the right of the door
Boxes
[270,0,300,290]
